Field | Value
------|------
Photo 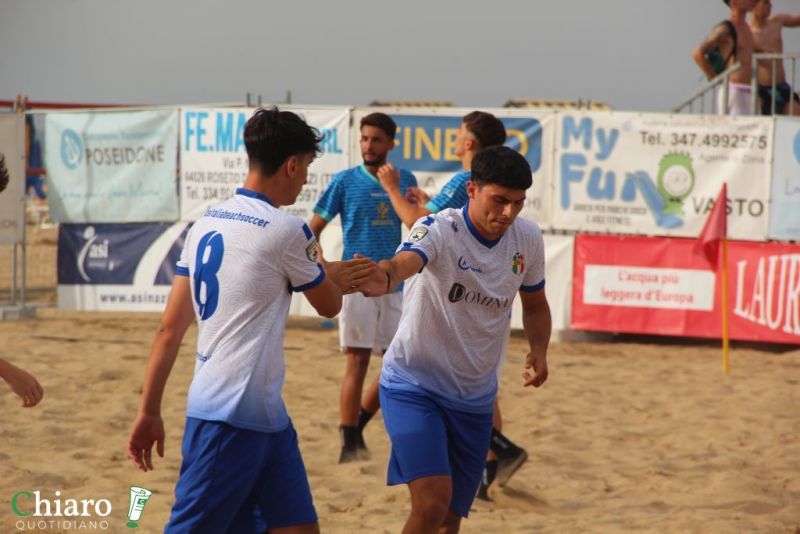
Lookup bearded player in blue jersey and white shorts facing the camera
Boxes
[309,113,417,463]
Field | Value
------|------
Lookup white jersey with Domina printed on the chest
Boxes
[381,207,544,411]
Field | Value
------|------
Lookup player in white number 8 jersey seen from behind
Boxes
[128,108,376,534]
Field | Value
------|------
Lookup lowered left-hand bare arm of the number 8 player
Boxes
[128,276,194,471]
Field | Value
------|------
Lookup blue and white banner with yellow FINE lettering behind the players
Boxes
[351,108,555,229]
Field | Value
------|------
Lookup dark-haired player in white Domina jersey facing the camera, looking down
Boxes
[360,146,551,532]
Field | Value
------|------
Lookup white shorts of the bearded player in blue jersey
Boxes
[339,291,403,354]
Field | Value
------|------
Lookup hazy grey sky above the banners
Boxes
[0,0,800,111]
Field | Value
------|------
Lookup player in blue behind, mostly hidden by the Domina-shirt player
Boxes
[376,111,528,500]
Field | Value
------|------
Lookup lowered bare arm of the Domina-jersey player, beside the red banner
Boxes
[519,289,552,388]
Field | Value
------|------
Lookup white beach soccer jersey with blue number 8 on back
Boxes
[178,189,325,432]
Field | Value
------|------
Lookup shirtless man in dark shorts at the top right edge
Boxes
[750,0,800,115]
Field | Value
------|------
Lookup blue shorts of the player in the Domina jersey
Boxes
[380,386,492,517]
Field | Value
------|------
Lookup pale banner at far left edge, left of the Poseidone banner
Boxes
[0,113,25,245]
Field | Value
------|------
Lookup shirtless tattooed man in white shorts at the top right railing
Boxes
[693,0,758,115]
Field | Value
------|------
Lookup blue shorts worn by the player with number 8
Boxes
[164,417,317,534]
